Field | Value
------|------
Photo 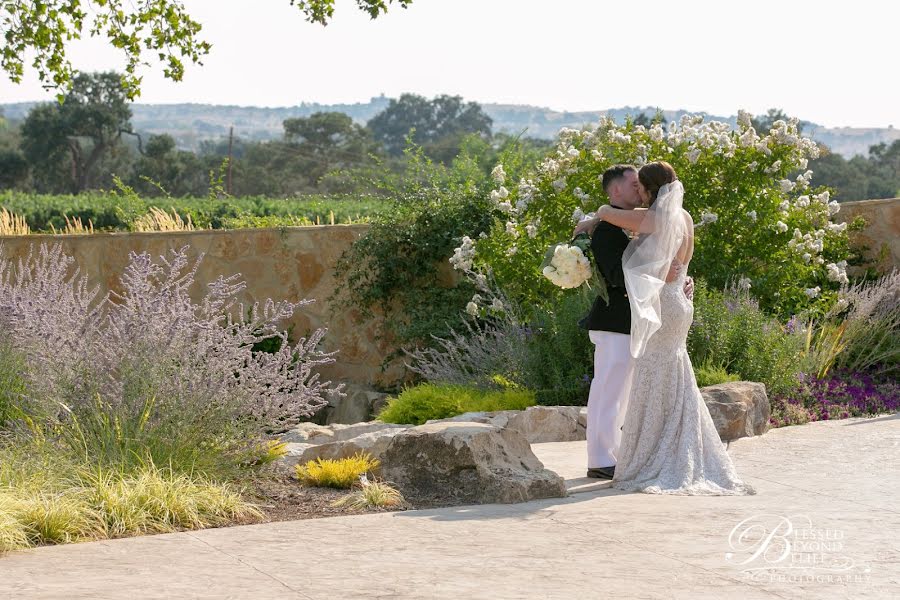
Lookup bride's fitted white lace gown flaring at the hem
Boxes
[613,268,756,496]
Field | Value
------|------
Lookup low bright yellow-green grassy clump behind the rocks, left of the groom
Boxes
[377,383,535,425]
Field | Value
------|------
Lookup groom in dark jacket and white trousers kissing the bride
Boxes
[575,165,693,479]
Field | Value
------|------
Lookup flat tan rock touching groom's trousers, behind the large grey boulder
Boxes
[426,406,587,444]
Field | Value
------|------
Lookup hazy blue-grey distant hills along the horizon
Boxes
[0,96,900,158]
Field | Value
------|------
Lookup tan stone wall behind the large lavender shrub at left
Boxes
[0,225,402,386]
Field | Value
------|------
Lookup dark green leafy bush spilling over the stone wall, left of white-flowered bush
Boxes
[332,137,537,358]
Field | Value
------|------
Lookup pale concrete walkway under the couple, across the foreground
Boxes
[0,415,900,600]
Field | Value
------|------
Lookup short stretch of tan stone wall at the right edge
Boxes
[837,198,900,273]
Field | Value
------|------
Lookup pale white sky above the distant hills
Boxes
[0,0,900,127]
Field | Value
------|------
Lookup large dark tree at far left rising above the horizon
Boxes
[22,72,132,193]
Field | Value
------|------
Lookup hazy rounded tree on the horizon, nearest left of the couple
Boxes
[366,94,492,158]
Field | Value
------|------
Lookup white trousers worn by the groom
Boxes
[587,331,634,468]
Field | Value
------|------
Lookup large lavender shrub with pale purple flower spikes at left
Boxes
[0,245,341,470]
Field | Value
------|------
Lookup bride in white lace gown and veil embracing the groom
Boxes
[597,161,755,495]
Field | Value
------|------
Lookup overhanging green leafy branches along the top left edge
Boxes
[0,0,412,101]
